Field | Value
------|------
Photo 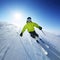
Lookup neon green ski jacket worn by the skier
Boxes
[22,22,42,33]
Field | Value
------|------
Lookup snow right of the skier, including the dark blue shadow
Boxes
[36,30,60,60]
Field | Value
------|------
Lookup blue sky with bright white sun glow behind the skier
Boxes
[0,0,60,34]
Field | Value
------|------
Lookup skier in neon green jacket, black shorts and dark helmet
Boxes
[20,17,44,43]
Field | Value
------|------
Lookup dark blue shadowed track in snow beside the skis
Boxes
[36,38,60,60]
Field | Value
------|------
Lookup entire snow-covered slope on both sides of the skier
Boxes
[0,22,60,60]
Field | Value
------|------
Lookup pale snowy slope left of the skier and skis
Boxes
[0,22,49,60]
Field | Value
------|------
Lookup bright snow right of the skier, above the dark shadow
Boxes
[37,31,60,52]
